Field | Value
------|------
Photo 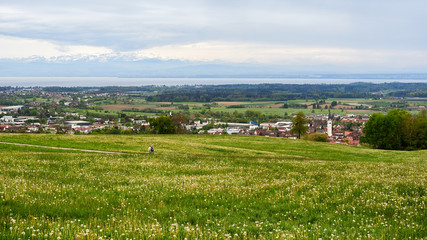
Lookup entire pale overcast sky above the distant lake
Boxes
[0,0,427,76]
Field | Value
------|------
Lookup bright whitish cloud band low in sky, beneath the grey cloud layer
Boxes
[0,35,427,68]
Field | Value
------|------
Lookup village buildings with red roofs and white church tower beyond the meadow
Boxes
[0,105,369,145]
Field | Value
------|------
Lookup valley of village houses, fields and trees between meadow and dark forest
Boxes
[0,86,426,145]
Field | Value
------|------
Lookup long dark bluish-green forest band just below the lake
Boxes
[147,83,427,102]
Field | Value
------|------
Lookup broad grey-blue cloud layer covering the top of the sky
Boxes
[0,0,427,50]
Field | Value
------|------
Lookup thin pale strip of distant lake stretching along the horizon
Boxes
[0,77,427,87]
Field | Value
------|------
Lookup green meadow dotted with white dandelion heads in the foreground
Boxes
[0,134,427,239]
